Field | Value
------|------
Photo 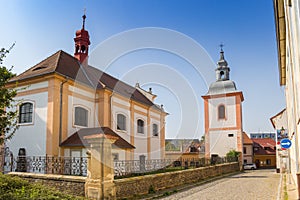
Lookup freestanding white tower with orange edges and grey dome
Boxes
[202,48,244,158]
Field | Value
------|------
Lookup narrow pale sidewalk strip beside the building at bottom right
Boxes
[281,174,298,200]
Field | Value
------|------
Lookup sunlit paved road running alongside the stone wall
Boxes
[163,170,280,200]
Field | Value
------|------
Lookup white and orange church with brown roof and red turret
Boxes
[5,15,167,160]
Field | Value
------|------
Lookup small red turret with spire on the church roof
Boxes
[74,14,91,65]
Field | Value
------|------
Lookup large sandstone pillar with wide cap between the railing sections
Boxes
[84,134,117,199]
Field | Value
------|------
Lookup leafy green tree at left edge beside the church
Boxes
[0,45,18,144]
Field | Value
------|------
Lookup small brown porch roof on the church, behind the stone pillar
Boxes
[60,127,135,149]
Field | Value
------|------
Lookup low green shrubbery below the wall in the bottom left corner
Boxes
[0,174,84,200]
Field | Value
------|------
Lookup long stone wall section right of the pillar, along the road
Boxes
[114,162,240,199]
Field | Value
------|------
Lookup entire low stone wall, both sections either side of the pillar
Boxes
[9,162,239,199]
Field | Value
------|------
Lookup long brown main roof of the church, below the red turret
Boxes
[10,50,164,111]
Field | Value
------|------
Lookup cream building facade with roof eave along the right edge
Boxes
[273,0,300,194]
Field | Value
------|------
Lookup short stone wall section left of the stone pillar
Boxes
[9,172,86,196]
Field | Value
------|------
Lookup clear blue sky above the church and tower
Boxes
[0,0,285,138]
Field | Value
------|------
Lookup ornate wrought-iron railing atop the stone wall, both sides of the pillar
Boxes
[3,152,237,177]
